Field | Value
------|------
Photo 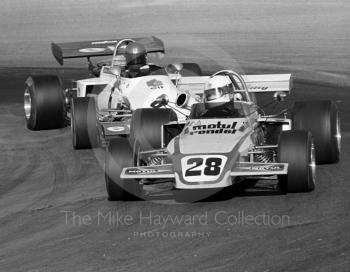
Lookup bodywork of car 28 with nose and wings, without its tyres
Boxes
[121,71,292,189]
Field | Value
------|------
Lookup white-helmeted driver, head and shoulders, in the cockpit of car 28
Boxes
[196,75,242,118]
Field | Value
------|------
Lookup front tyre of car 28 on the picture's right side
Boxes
[277,130,316,194]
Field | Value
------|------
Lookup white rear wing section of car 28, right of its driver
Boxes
[242,74,293,93]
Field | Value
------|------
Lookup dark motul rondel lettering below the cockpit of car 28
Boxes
[184,121,237,135]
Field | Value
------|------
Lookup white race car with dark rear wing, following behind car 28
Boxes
[24,37,201,149]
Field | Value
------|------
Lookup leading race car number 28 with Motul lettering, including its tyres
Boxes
[105,70,341,201]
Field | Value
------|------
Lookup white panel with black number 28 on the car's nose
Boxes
[181,155,227,181]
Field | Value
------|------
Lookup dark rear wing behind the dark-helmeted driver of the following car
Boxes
[51,36,165,65]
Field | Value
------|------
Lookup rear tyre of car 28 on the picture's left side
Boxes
[130,108,177,150]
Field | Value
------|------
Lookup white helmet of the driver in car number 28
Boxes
[203,75,235,108]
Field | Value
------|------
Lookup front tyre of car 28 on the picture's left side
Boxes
[105,138,142,201]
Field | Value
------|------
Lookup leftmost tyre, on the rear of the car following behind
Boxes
[24,75,66,130]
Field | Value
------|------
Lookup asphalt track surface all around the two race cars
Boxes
[0,1,350,272]
